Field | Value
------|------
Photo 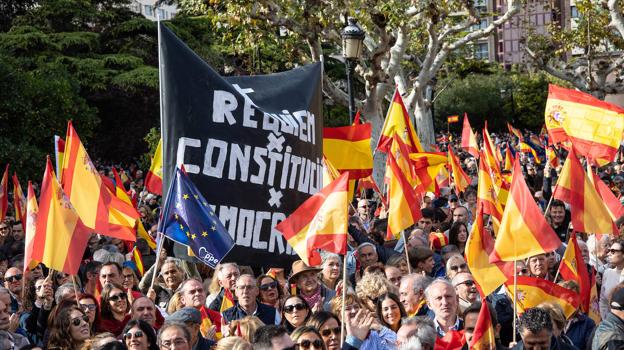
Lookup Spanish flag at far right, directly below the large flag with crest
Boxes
[553,149,618,234]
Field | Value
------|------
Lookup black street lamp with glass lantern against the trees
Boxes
[342,17,366,124]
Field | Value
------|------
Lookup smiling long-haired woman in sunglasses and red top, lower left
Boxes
[99,283,130,336]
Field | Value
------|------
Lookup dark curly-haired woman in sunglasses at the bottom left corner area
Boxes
[47,305,91,350]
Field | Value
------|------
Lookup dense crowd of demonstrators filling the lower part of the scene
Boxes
[0,130,624,350]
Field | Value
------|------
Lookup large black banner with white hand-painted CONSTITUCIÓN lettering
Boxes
[160,24,323,267]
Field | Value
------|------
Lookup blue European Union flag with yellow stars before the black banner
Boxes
[159,168,234,269]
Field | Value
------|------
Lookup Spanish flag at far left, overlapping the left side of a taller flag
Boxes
[27,157,91,275]
